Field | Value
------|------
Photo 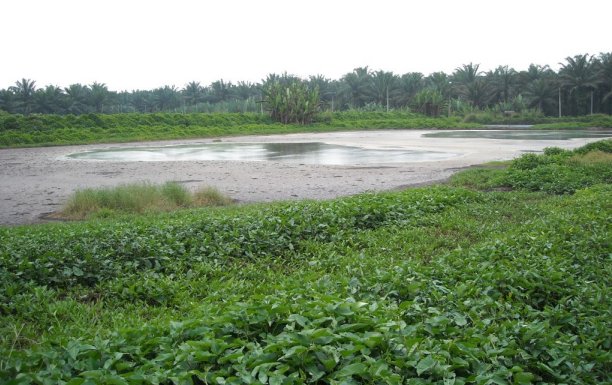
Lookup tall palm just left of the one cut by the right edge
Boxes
[559,54,597,114]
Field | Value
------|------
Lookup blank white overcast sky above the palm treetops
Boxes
[0,0,612,90]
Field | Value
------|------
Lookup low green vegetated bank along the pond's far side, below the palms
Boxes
[0,112,479,148]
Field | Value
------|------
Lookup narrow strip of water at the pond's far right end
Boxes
[423,130,612,140]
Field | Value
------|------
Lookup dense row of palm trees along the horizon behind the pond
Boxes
[0,53,612,117]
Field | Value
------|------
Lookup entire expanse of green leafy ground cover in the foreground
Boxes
[0,141,612,384]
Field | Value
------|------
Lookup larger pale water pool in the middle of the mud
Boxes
[69,143,460,165]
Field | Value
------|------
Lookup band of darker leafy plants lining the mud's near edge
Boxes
[0,186,473,292]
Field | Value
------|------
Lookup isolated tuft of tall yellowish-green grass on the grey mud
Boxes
[57,182,231,219]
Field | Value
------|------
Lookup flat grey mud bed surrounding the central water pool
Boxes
[0,130,599,225]
